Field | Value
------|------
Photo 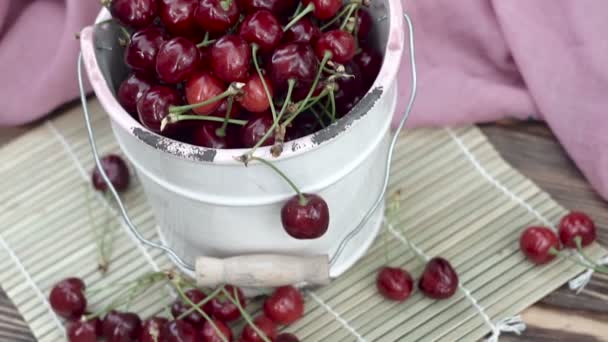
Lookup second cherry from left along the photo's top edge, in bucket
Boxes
[158,0,204,40]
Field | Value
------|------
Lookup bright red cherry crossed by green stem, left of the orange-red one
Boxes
[186,71,226,115]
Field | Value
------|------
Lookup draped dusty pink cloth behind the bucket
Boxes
[0,0,608,198]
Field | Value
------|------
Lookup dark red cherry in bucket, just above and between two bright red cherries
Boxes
[211,35,251,83]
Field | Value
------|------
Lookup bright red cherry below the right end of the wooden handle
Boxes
[264,286,304,325]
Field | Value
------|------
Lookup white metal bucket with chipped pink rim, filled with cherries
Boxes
[81,0,404,277]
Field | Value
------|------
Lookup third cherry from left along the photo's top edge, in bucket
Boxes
[195,0,240,33]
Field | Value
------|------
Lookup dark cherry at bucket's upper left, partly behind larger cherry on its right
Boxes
[125,27,167,75]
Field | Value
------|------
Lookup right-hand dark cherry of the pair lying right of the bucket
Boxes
[418,258,458,299]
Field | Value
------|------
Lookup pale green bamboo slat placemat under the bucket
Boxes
[0,100,606,342]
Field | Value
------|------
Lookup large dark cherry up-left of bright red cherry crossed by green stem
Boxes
[156,37,200,84]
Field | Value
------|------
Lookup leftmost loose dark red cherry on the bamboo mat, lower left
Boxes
[49,278,87,318]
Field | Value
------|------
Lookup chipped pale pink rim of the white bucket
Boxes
[80,0,405,165]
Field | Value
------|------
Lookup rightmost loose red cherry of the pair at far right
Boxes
[559,211,597,248]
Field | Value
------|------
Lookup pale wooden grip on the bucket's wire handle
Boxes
[195,254,329,287]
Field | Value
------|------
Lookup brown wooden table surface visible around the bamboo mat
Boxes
[0,108,608,342]
